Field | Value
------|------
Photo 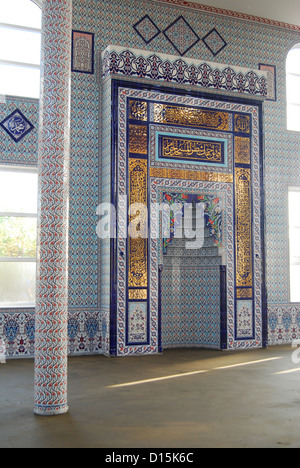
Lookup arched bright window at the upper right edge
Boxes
[286,44,300,132]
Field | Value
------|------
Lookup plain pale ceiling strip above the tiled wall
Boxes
[184,0,300,26]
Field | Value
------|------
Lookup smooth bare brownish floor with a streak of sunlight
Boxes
[0,346,300,449]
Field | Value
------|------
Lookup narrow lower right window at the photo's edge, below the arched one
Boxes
[289,188,300,302]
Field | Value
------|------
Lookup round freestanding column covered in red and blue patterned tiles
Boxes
[34,0,72,416]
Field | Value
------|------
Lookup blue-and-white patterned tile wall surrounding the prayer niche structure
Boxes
[0,0,300,355]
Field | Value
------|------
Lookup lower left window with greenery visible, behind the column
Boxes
[0,167,38,308]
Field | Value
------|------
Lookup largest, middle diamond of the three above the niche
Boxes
[164,16,200,55]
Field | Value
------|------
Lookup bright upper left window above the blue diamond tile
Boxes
[0,0,41,99]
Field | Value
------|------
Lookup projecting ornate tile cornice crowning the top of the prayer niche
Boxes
[102,46,268,98]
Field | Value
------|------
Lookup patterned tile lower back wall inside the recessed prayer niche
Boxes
[162,264,220,349]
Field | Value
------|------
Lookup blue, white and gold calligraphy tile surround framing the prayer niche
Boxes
[105,81,266,356]
